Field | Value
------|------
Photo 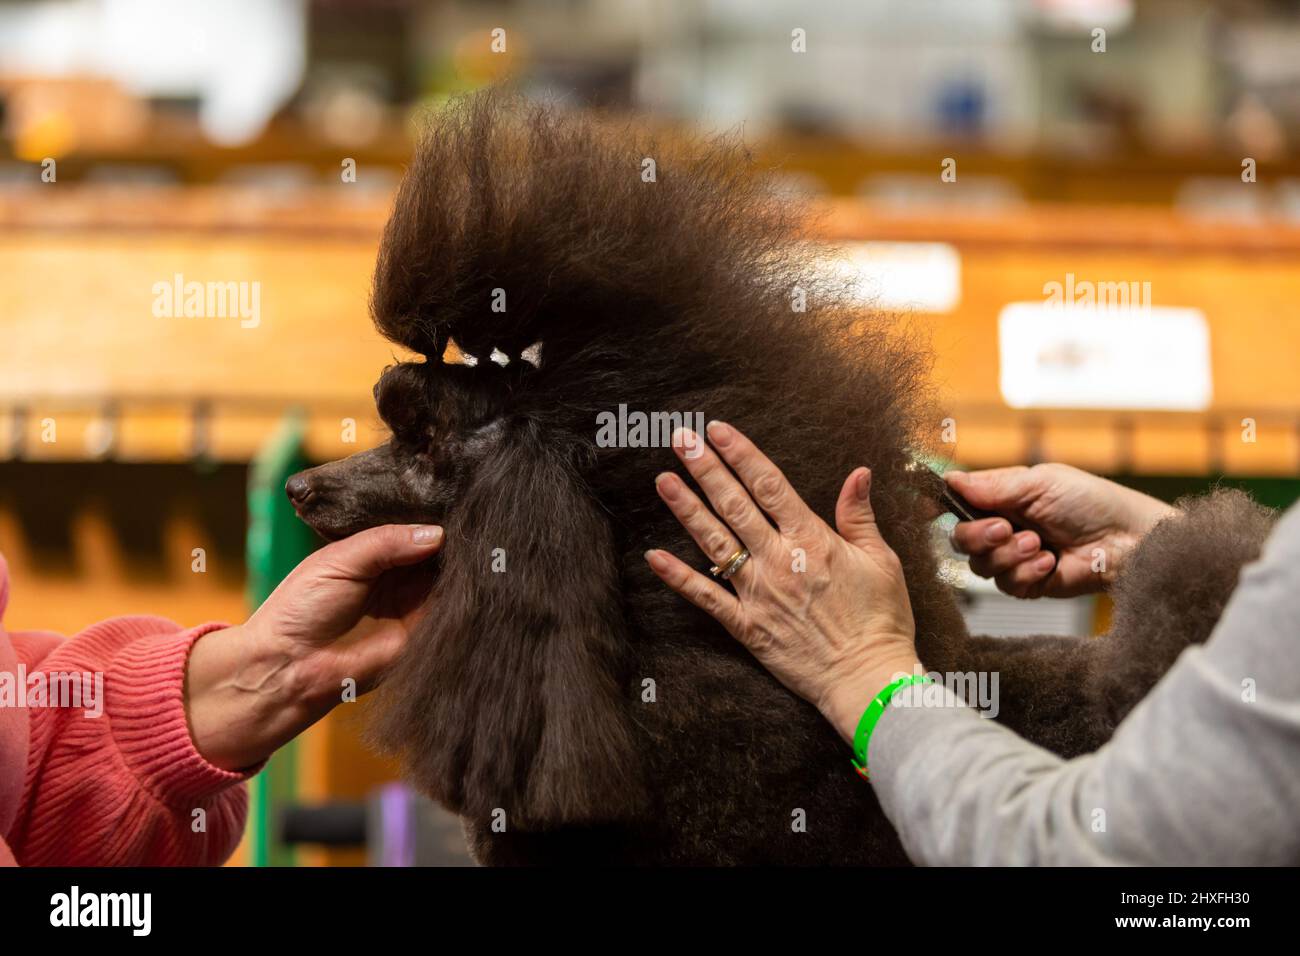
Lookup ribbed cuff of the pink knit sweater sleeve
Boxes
[104,623,263,805]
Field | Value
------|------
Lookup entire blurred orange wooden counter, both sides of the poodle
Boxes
[0,183,1300,475]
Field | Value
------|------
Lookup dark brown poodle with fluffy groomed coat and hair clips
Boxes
[289,94,1270,864]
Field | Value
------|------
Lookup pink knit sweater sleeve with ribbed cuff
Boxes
[4,617,257,866]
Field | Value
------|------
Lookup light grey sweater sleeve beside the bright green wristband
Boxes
[867,506,1300,865]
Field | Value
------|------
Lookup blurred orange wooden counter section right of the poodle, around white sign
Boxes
[822,202,1300,475]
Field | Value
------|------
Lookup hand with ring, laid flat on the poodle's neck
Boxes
[646,421,919,741]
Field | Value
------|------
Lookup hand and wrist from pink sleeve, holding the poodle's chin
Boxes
[185,524,442,770]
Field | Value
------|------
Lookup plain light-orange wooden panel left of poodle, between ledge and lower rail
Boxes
[0,233,405,402]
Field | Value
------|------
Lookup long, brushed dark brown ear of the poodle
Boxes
[376,436,646,830]
